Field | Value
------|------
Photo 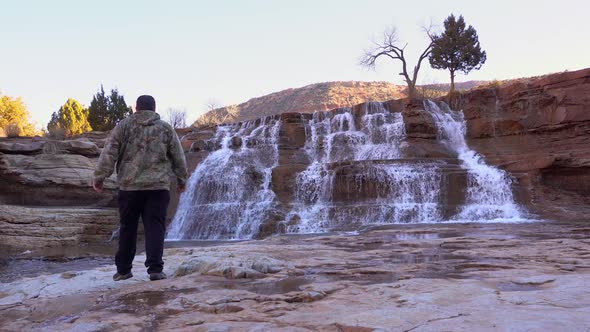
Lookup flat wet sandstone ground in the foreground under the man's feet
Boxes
[0,221,590,331]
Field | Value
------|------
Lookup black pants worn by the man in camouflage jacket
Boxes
[115,190,170,274]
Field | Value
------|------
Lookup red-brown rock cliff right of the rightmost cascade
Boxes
[460,69,590,219]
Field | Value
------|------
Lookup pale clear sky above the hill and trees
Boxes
[0,0,590,125]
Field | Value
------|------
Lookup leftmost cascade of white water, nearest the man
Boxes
[168,117,281,240]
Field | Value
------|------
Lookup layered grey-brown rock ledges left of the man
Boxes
[0,133,118,249]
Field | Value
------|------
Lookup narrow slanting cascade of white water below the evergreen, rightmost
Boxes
[424,100,523,222]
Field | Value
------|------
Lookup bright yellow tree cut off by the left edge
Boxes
[0,96,39,136]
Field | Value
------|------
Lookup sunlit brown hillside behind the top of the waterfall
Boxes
[193,81,406,127]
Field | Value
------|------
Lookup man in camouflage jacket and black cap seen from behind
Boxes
[92,95,187,281]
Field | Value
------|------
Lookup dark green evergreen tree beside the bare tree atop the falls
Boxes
[429,14,486,95]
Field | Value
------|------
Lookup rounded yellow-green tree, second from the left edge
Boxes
[47,98,92,136]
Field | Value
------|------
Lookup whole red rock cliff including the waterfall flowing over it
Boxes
[172,70,590,238]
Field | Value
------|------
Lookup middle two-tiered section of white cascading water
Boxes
[287,103,441,233]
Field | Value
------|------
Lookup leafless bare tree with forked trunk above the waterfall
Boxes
[360,26,432,97]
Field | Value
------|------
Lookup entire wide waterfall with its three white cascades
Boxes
[168,101,524,240]
